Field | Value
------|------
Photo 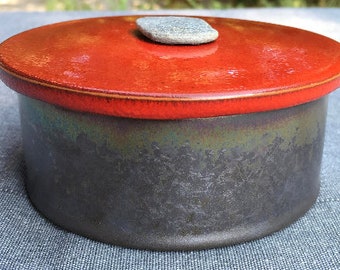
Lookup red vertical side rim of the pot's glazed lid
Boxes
[0,69,340,120]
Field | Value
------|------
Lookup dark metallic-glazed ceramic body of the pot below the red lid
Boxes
[19,95,327,250]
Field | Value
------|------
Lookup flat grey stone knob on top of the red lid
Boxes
[136,16,218,45]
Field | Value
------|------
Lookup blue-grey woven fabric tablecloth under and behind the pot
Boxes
[0,8,340,270]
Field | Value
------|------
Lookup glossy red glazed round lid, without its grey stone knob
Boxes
[0,16,340,119]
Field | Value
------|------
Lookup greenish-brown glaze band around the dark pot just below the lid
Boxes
[21,96,326,159]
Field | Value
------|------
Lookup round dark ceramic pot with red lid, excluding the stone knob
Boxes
[0,16,340,250]
